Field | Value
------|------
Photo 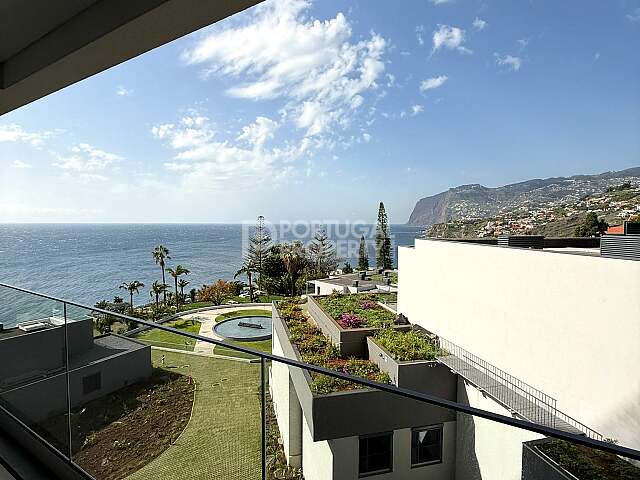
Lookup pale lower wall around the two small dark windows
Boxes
[302,422,456,480]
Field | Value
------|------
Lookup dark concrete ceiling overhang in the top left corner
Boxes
[0,0,262,115]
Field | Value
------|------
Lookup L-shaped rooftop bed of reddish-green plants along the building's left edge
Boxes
[278,300,391,394]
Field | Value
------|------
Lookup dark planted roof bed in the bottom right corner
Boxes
[538,440,640,480]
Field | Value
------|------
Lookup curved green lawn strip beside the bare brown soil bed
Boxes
[127,351,261,480]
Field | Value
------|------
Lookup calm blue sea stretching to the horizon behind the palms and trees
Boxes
[0,224,420,312]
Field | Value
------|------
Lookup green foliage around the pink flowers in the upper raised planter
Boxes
[316,293,396,328]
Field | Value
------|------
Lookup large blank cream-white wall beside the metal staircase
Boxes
[398,240,640,448]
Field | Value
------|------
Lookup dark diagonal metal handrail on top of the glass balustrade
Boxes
[0,282,640,460]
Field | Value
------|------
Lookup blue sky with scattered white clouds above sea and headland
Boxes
[0,0,640,223]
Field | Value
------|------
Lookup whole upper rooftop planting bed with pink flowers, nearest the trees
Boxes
[316,293,396,328]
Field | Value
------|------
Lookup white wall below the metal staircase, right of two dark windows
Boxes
[456,377,542,480]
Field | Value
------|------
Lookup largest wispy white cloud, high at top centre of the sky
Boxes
[183,0,387,136]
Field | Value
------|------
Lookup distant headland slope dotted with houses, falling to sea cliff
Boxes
[407,167,640,226]
